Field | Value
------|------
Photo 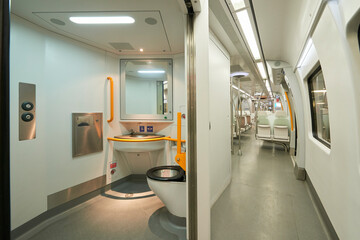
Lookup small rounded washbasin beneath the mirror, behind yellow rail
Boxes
[114,133,165,152]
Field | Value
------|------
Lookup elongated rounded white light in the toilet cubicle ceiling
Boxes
[69,16,135,24]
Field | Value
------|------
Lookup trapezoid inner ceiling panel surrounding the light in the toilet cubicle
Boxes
[34,11,171,54]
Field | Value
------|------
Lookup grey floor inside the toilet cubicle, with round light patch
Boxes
[29,176,186,240]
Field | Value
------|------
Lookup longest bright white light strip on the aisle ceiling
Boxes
[236,9,260,60]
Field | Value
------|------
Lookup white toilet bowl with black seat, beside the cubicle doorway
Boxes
[146,165,186,217]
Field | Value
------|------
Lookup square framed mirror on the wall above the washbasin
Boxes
[120,59,173,120]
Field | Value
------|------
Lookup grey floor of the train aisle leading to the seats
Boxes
[211,131,328,240]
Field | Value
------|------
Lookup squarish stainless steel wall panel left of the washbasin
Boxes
[72,113,103,157]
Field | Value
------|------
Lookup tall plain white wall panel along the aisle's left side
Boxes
[209,38,231,205]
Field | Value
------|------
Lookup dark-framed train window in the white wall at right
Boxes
[308,67,331,148]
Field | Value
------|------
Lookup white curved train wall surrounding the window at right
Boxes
[299,5,360,239]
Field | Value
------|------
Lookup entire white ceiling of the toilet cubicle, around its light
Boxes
[11,0,185,54]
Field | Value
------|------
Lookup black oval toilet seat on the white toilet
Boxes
[146,166,185,182]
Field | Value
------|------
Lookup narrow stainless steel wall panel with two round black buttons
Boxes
[19,83,36,141]
